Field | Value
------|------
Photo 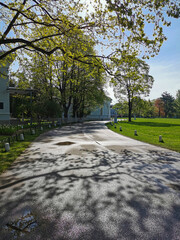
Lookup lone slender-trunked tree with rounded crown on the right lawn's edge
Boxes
[112,52,154,122]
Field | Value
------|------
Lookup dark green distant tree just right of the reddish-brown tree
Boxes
[160,92,175,117]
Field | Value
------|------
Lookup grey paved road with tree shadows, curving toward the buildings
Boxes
[0,122,180,240]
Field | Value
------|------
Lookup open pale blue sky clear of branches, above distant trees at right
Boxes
[108,16,180,103]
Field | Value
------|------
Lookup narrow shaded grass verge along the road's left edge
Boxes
[0,129,50,173]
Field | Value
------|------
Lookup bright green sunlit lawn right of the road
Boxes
[106,118,180,152]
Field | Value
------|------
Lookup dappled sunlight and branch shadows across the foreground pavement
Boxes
[0,146,180,240]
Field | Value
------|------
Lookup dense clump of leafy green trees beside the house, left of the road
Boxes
[13,32,105,118]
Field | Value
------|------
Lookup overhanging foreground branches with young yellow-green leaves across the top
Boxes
[0,0,180,61]
